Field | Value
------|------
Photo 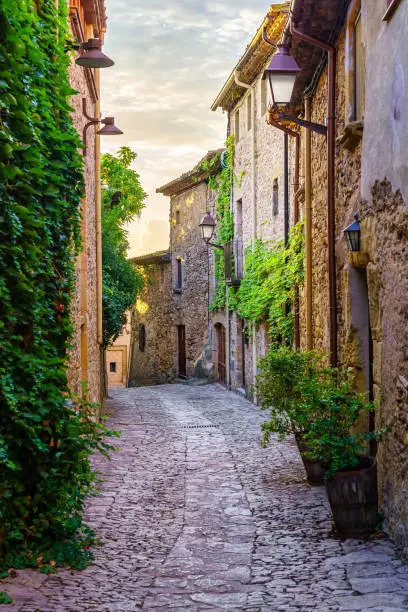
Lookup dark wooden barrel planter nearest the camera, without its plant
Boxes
[326,457,378,538]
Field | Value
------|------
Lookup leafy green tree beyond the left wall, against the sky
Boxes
[101,147,146,347]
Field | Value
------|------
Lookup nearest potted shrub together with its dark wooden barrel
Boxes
[304,370,382,537]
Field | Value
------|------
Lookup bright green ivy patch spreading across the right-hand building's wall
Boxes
[235,223,304,345]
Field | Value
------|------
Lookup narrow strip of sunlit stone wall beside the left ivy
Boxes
[68,47,101,401]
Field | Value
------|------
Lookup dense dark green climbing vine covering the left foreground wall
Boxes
[0,0,115,571]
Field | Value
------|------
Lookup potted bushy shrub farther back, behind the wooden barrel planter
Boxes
[256,346,329,485]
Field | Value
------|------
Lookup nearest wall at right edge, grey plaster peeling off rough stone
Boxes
[361,0,408,557]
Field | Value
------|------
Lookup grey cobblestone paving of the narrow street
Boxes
[0,385,408,612]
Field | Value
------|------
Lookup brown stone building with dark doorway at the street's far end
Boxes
[129,151,221,386]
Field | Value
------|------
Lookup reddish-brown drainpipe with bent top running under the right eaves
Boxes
[290,22,338,367]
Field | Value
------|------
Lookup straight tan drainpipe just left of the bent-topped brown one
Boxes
[305,97,313,351]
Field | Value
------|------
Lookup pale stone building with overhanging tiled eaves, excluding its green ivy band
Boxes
[211,3,295,393]
